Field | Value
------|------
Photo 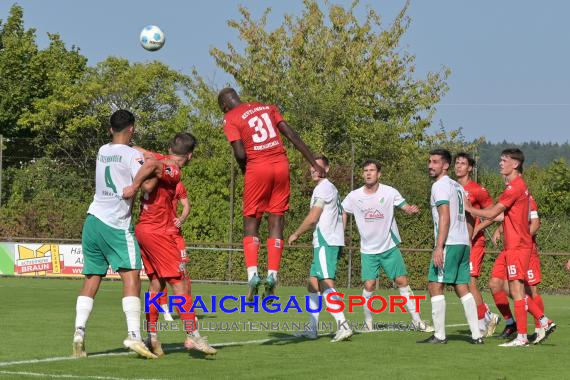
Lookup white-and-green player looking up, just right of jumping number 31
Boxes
[288,156,353,342]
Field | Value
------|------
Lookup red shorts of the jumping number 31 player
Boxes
[243,160,290,218]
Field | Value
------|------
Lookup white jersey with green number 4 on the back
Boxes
[87,143,144,230]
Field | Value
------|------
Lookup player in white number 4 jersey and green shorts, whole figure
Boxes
[73,110,157,359]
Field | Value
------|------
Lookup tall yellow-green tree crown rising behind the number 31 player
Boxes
[211,0,449,170]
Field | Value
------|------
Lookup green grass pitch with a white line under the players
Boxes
[0,278,570,380]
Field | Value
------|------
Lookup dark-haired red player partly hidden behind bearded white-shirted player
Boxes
[454,152,500,337]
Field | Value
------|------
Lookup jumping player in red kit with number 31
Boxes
[218,88,325,301]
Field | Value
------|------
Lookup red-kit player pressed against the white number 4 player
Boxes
[124,133,216,356]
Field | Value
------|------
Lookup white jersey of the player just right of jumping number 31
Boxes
[311,178,344,248]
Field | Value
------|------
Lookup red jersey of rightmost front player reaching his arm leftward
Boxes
[499,176,532,250]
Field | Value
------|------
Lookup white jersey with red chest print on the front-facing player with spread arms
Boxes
[342,184,406,254]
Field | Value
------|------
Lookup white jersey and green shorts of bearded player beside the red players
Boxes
[428,175,471,284]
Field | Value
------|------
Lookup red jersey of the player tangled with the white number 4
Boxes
[138,153,180,233]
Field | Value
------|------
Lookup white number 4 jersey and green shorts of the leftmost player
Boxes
[82,143,144,275]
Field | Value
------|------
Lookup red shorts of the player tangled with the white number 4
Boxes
[135,226,186,278]
